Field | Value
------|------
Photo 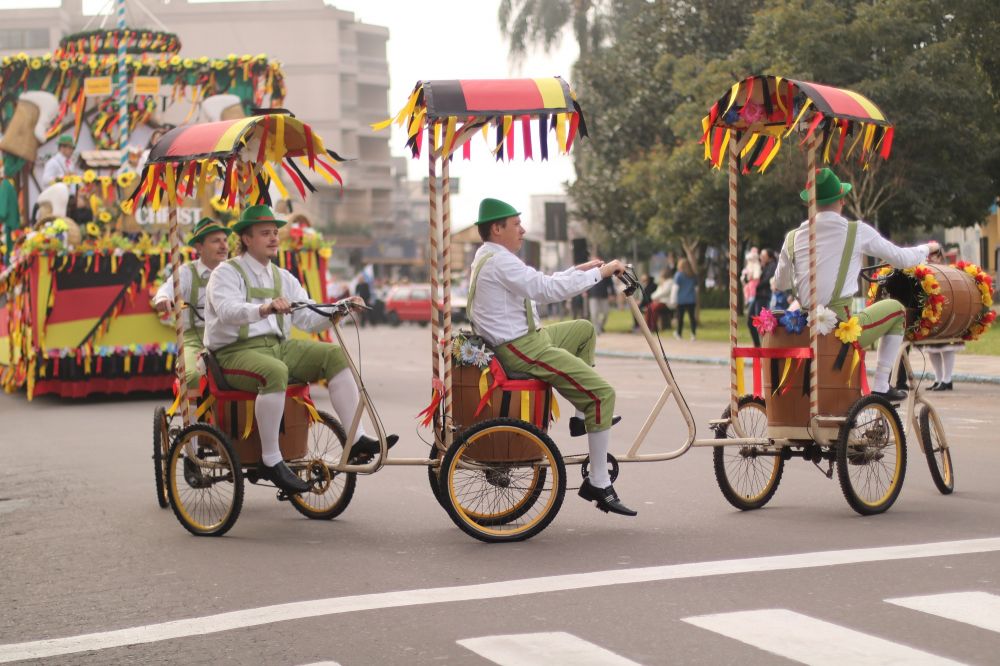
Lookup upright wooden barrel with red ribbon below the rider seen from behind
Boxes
[761,326,861,428]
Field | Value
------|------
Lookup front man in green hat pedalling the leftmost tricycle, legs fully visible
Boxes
[205,205,398,493]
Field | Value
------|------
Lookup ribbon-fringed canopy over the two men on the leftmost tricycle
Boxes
[123,112,343,210]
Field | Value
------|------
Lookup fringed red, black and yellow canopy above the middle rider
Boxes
[372,77,587,160]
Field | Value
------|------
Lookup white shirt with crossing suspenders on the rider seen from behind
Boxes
[774,211,929,309]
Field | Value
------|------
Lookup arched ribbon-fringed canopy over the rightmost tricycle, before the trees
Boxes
[702,76,893,173]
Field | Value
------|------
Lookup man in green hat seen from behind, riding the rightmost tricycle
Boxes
[774,168,939,402]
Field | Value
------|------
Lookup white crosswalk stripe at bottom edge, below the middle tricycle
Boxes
[455,631,641,666]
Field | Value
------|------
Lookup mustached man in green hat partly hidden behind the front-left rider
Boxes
[153,217,233,389]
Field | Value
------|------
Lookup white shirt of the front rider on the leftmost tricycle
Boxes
[205,254,332,349]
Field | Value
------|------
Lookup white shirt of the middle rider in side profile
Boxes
[472,243,601,346]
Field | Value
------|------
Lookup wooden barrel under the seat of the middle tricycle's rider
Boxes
[452,366,545,463]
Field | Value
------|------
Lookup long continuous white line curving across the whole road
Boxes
[0,537,1000,663]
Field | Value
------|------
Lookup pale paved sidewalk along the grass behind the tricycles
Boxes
[597,333,1000,385]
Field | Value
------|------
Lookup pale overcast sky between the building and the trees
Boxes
[0,0,586,229]
